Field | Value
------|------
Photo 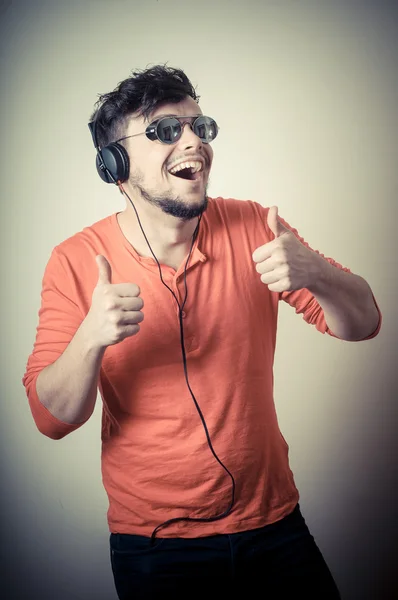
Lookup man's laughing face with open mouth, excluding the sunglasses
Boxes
[124,97,213,221]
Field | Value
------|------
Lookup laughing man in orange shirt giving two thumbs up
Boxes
[24,66,381,600]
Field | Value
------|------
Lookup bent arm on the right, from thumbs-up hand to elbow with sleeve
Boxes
[253,207,381,341]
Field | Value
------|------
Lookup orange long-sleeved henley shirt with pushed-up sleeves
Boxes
[23,198,380,538]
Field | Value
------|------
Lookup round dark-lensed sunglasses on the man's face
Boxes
[116,115,219,144]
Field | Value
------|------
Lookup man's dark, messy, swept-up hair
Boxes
[90,65,199,148]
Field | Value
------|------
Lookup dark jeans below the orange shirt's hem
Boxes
[110,505,340,600]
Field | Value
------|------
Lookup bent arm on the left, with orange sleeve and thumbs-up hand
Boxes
[23,251,143,439]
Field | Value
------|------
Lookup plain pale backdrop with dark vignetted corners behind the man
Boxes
[0,0,398,600]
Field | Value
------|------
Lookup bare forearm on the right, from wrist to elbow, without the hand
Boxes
[308,255,379,341]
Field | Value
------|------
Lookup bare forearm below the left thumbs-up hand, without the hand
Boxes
[36,321,104,423]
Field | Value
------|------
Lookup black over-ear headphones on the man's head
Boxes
[88,117,130,185]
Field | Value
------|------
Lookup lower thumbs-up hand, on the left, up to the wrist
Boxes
[85,254,144,349]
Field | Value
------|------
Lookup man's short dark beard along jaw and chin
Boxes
[129,173,209,221]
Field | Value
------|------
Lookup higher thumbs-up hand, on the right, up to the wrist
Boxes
[252,206,323,292]
